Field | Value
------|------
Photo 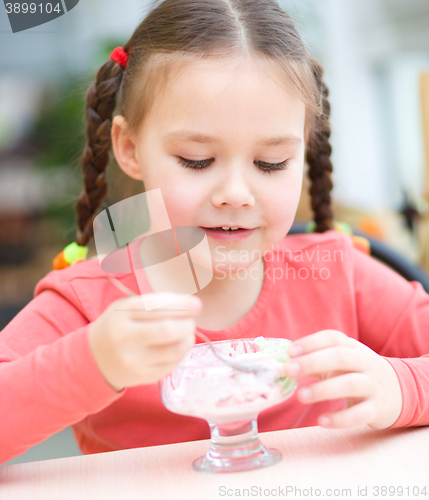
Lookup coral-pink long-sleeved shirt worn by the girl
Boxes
[0,231,429,463]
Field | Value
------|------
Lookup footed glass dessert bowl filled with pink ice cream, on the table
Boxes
[160,337,297,472]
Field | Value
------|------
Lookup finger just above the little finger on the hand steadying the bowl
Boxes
[297,373,373,404]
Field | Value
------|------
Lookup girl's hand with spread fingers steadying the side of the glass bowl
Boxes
[285,330,402,429]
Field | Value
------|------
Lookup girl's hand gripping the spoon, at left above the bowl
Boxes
[89,294,202,391]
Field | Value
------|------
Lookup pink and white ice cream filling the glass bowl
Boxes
[161,337,296,424]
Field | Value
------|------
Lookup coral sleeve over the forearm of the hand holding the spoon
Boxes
[0,284,125,463]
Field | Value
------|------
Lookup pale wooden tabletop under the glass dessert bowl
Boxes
[0,427,429,500]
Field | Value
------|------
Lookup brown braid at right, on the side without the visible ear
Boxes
[306,59,333,233]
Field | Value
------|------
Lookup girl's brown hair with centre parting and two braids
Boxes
[76,0,333,245]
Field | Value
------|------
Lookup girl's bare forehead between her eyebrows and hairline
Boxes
[142,56,305,131]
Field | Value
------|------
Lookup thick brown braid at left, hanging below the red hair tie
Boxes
[75,59,124,246]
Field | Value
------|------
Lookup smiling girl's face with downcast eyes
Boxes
[112,58,305,273]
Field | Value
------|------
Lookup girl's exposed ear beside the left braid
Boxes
[112,115,143,181]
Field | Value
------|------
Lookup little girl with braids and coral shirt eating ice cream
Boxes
[0,0,429,462]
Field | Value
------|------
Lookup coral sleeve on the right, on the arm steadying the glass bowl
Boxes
[353,246,429,427]
